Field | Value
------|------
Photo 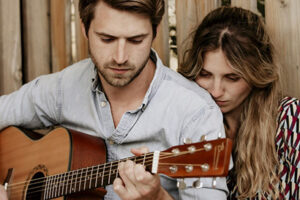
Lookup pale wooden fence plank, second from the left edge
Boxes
[22,0,50,82]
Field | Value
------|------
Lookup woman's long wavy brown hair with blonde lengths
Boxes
[178,7,281,199]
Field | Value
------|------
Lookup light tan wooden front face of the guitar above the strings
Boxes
[0,127,71,200]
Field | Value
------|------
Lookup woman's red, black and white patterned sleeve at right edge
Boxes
[276,97,300,199]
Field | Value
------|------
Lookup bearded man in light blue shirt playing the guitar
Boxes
[0,0,227,200]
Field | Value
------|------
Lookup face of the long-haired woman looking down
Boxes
[196,49,251,114]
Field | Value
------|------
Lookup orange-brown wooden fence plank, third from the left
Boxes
[50,0,72,72]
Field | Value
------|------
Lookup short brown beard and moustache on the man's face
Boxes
[89,47,150,87]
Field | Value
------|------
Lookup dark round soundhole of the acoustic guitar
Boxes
[25,172,45,200]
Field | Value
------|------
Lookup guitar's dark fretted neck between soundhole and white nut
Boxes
[44,152,154,199]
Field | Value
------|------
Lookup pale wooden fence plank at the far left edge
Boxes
[0,0,22,95]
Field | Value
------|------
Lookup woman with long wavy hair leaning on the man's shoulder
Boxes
[178,7,300,199]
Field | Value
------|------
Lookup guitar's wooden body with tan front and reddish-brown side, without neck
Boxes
[0,127,106,200]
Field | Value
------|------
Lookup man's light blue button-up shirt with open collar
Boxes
[0,52,227,200]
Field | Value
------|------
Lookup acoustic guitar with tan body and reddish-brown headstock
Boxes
[0,126,232,200]
